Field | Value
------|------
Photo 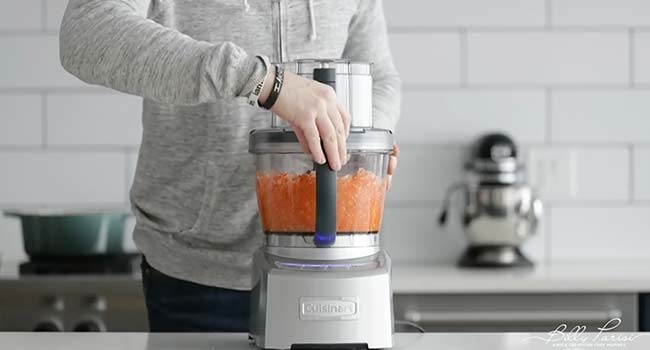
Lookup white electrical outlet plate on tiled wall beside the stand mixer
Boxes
[528,148,577,200]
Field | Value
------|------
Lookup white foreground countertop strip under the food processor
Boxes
[0,333,650,350]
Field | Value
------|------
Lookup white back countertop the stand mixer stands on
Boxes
[392,260,650,294]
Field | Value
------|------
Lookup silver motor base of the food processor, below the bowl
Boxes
[250,248,393,349]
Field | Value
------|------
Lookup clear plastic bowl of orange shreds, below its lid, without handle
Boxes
[256,152,388,235]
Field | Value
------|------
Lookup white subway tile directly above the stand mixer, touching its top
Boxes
[397,89,545,144]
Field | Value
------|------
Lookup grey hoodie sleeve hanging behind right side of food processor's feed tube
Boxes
[343,0,402,131]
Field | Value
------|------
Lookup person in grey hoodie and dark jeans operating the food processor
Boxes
[60,0,401,332]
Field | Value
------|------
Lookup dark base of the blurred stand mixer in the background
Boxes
[458,245,533,267]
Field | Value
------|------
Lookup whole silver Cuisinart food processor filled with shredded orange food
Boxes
[249,60,393,349]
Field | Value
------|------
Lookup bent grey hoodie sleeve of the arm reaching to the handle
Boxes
[59,0,266,105]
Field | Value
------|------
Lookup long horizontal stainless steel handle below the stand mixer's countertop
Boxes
[404,309,623,324]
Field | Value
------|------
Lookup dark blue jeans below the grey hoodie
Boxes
[141,258,250,332]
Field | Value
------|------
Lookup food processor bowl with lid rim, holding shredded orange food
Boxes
[250,129,392,235]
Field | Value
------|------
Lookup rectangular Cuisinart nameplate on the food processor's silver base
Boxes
[300,297,359,320]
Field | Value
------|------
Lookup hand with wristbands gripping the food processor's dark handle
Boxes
[260,68,351,170]
